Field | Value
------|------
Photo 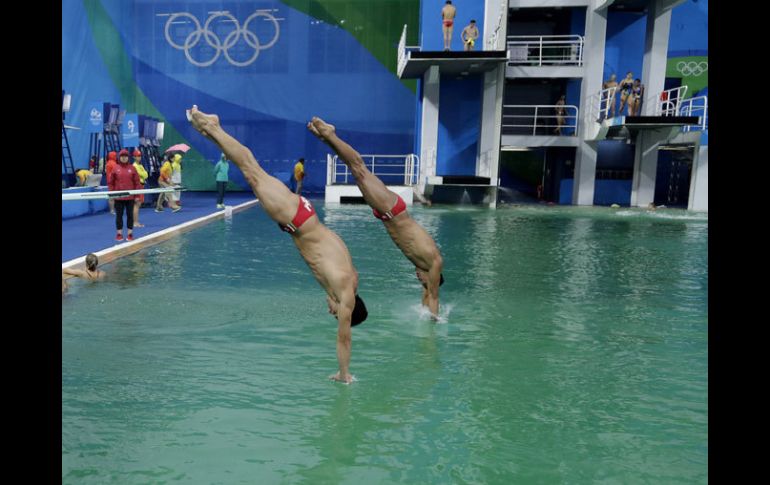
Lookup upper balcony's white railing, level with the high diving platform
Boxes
[508,35,584,66]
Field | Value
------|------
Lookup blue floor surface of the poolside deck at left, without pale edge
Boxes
[61,192,255,263]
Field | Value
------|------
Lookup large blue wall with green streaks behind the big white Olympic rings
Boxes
[62,0,415,194]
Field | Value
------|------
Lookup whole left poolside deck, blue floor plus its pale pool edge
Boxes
[61,192,259,269]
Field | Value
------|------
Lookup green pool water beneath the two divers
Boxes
[62,201,708,485]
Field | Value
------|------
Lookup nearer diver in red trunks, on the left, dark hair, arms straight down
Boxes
[188,106,367,384]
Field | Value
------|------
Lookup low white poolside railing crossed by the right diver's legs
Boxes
[326,153,420,185]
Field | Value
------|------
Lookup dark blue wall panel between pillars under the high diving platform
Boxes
[436,75,476,175]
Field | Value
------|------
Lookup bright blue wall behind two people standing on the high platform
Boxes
[420,0,484,51]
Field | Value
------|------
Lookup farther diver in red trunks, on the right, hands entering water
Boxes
[307,117,444,319]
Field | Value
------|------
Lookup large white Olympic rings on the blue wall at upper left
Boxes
[165,10,281,67]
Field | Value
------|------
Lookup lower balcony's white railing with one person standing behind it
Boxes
[502,104,578,136]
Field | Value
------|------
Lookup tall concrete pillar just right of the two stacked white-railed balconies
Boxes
[572,8,607,205]
